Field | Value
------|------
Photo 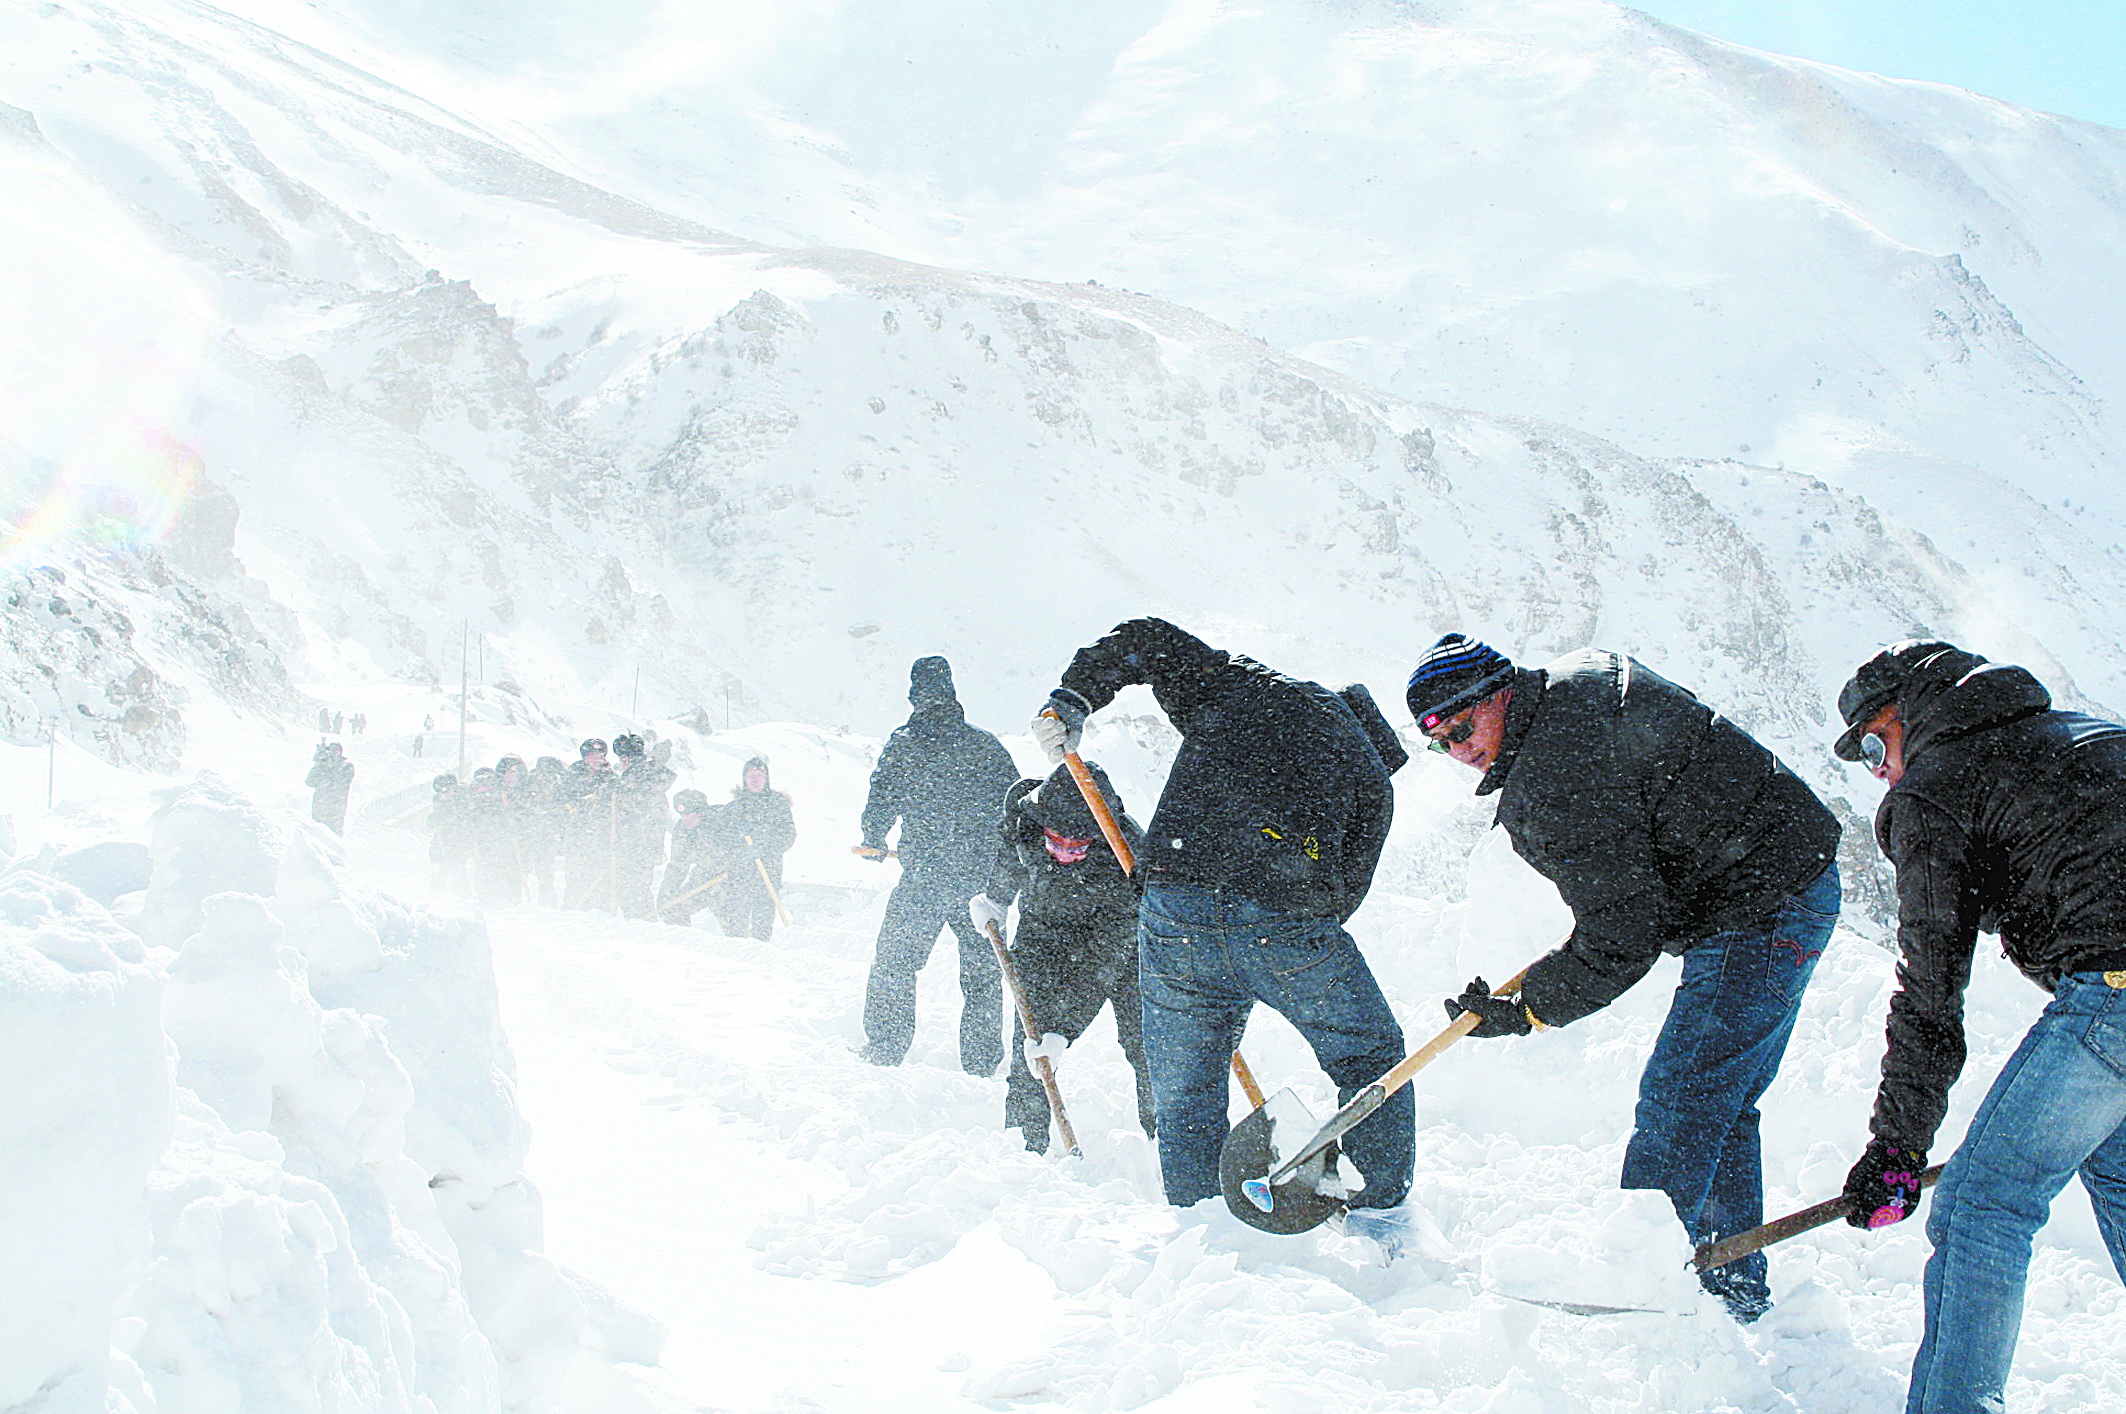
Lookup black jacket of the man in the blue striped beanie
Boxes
[1478,649,1839,1025]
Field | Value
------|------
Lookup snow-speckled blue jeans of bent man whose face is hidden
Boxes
[1137,882,1418,1208]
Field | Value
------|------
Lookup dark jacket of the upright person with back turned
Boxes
[863,700,1018,882]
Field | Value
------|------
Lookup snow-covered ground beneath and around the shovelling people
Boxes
[0,710,2126,1414]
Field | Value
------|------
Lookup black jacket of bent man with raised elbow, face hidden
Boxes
[1059,619,1395,923]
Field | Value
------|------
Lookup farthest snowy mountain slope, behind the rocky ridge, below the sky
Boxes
[308,0,2126,510]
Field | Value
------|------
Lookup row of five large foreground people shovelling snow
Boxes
[859,619,2126,1414]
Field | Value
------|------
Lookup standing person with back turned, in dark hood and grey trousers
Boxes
[859,657,1018,1076]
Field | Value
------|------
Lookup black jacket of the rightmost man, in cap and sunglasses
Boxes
[1869,663,2126,1152]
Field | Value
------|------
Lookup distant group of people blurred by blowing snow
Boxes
[427,734,797,940]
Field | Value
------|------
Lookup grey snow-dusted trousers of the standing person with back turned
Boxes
[863,872,1003,1076]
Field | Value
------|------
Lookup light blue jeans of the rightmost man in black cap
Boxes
[1905,972,2126,1414]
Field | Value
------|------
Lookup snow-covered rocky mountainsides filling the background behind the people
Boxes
[4,0,2126,778]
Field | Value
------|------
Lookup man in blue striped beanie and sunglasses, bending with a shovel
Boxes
[1407,634,1839,1320]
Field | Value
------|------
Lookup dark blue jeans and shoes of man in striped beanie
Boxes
[1622,865,1839,1318]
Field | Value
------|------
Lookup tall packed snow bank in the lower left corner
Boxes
[0,778,657,1414]
